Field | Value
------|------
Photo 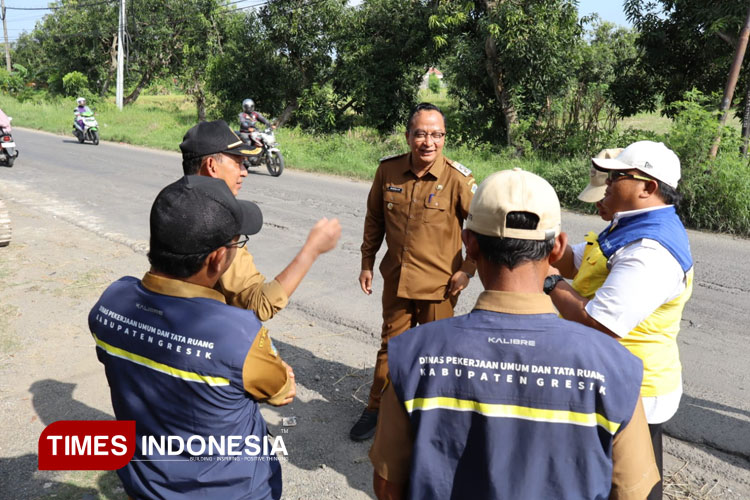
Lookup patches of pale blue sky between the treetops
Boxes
[5,0,629,41]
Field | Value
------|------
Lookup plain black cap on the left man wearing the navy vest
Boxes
[150,175,263,255]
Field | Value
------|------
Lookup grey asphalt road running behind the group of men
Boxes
[0,128,750,459]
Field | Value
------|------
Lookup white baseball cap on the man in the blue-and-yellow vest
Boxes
[591,141,680,189]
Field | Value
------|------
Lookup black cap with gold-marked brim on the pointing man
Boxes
[180,120,252,160]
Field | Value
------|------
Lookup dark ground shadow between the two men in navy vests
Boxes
[270,339,372,495]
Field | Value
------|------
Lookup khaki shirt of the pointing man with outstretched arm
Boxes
[214,248,289,321]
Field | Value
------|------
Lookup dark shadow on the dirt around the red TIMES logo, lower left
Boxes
[0,379,120,500]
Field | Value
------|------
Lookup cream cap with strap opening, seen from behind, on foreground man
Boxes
[466,168,561,241]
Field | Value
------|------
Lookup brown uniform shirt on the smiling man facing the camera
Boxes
[361,153,476,300]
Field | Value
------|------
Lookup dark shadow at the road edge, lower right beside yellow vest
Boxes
[666,394,750,470]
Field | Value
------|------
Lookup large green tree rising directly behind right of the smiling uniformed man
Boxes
[430,0,582,145]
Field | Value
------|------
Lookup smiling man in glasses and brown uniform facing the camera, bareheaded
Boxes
[349,103,476,441]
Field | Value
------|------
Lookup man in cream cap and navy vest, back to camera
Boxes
[370,169,659,500]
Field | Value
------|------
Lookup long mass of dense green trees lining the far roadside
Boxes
[8,0,633,145]
